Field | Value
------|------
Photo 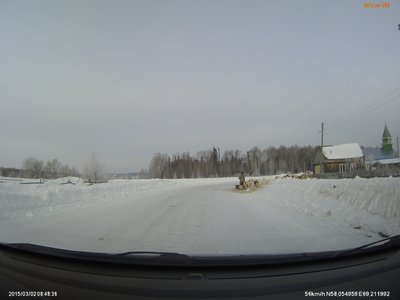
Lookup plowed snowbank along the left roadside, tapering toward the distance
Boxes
[0,177,176,220]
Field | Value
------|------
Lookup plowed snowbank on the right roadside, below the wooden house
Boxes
[263,178,400,237]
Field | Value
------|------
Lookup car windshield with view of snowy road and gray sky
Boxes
[0,0,400,256]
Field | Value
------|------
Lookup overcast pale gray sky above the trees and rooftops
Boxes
[0,0,400,172]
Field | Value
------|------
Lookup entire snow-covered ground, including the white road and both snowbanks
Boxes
[0,177,400,254]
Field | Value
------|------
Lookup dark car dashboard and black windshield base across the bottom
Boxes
[0,238,400,299]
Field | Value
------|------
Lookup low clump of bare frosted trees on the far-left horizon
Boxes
[20,157,79,179]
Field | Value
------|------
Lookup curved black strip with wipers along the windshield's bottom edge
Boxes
[0,235,400,267]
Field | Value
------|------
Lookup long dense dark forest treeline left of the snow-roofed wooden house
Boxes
[147,145,317,178]
